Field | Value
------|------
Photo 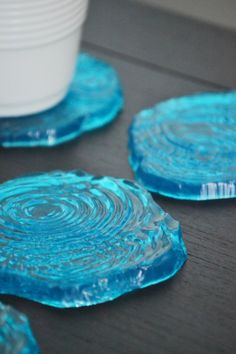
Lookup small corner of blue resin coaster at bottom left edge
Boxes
[0,302,39,354]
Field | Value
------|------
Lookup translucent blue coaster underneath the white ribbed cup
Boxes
[0,53,123,147]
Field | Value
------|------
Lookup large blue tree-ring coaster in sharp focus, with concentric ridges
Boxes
[0,171,187,307]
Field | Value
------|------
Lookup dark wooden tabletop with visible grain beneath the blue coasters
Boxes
[0,0,236,354]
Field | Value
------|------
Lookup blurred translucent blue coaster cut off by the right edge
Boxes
[129,91,236,200]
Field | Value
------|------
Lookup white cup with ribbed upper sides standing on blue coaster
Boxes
[0,0,88,118]
